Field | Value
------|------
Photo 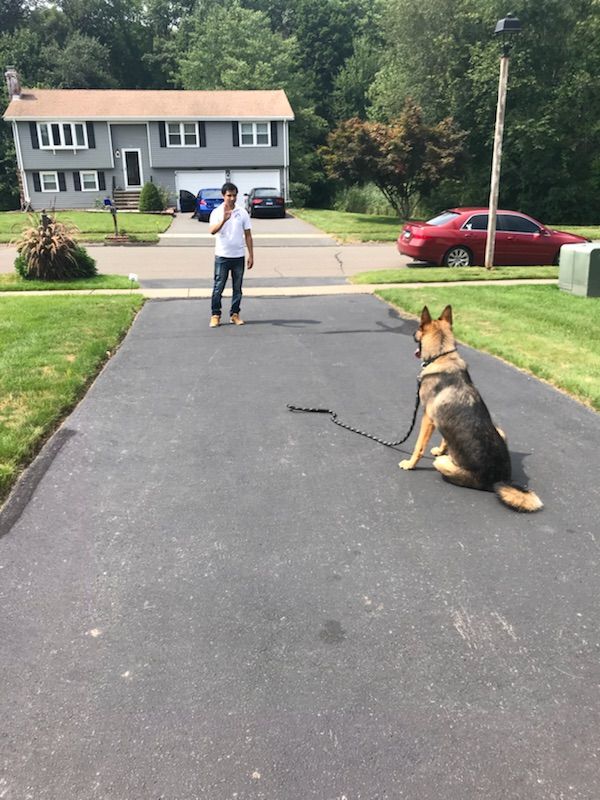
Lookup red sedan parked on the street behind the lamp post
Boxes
[397,208,589,267]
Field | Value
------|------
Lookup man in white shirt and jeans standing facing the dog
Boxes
[209,183,254,328]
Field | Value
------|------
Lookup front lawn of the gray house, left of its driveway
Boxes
[0,211,173,242]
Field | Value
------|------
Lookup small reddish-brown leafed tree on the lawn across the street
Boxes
[322,101,464,219]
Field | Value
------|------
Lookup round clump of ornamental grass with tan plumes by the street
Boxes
[15,212,97,281]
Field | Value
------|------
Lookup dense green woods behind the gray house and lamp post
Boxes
[0,0,600,223]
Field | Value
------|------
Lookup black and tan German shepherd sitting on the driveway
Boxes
[398,306,542,511]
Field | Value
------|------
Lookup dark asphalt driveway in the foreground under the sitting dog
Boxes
[0,296,600,800]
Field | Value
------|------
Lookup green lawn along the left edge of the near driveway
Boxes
[0,295,144,500]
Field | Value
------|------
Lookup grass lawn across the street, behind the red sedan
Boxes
[292,208,600,242]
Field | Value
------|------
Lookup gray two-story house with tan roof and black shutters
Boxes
[4,68,294,209]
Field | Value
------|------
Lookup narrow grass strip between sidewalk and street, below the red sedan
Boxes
[350,267,558,284]
